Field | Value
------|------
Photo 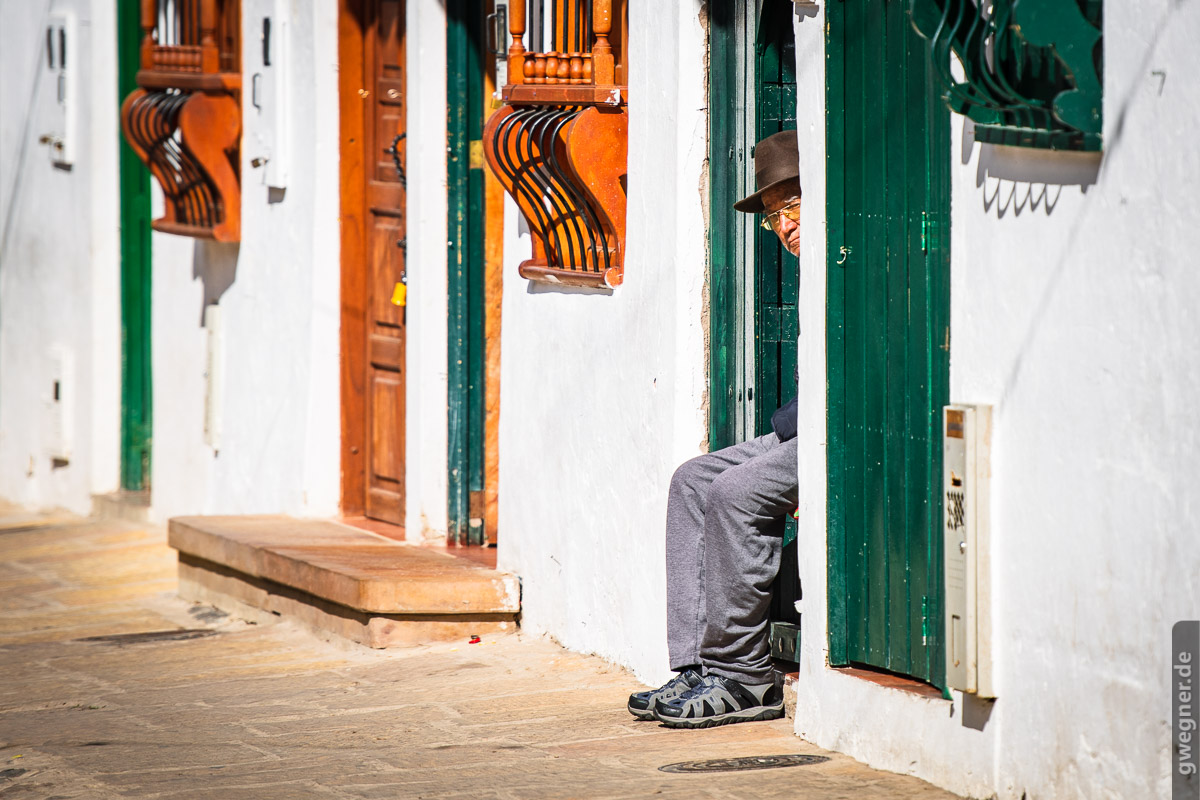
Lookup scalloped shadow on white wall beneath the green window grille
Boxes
[962,118,1103,219]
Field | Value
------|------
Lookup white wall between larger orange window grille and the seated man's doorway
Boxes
[499,2,707,681]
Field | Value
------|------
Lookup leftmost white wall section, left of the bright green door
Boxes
[0,0,120,513]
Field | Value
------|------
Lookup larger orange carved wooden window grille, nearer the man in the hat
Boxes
[484,0,629,287]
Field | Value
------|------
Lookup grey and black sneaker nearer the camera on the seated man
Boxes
[654,675,784,728]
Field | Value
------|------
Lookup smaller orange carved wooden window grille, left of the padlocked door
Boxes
[121,0,241,241]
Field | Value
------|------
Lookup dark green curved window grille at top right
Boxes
[910,0,1104,150]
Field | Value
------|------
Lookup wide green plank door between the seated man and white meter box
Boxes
[826,0,950,686]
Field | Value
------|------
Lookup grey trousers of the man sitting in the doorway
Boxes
[667,433,799,684]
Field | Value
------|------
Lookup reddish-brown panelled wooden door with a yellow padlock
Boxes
[340,0,407,525]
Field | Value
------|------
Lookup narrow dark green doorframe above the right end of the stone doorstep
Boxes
[446,0,485,545]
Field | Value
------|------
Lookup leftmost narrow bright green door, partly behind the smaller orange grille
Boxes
[116,0,154,492]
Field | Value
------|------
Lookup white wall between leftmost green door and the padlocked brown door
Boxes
[151,0,341,519]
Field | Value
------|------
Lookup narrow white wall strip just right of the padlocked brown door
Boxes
[404,1,449,541]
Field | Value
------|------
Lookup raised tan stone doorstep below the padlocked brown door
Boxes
[168,516,521,648]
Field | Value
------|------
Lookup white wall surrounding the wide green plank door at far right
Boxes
[796,1,1200,800]
